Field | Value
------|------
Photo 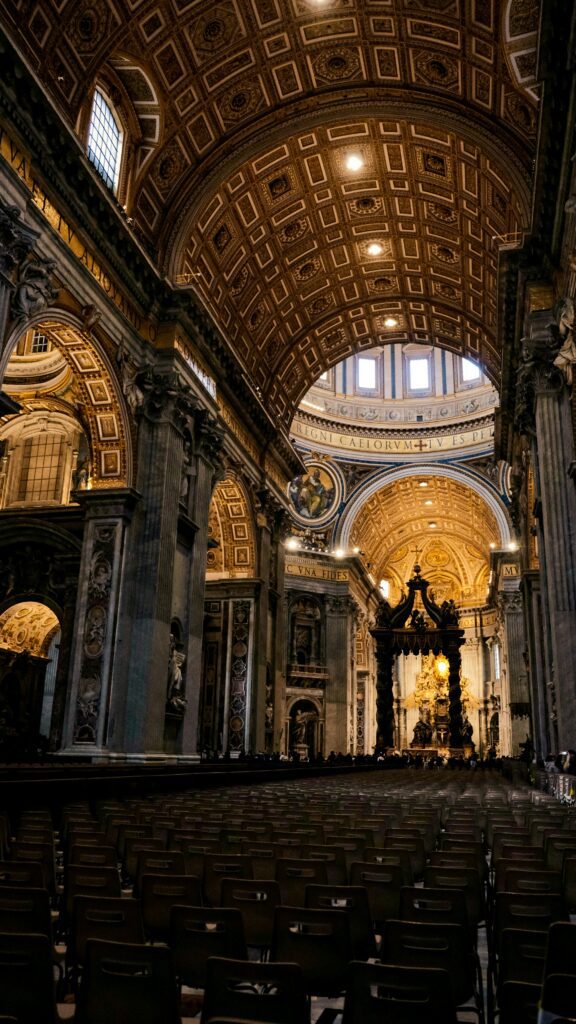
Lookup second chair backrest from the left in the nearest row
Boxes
[74,939,180,1024]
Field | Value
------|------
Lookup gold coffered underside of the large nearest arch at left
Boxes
[0,309,133,487]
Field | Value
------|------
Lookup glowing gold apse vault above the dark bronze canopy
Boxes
[351,476,500,606]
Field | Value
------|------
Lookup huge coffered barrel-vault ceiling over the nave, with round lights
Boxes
[4,0,539,423]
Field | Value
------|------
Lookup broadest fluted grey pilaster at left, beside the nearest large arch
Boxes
[113,368,195,755]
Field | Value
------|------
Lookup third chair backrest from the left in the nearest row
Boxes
[201,957,310,1024]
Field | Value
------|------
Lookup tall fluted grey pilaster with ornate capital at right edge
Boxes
[517,311,576,750]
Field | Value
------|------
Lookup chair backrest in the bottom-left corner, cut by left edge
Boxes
[0,932,56,1024]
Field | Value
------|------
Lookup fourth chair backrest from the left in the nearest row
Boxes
[342,962,457,1024]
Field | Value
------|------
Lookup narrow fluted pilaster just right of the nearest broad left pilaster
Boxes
[181,410,222,755]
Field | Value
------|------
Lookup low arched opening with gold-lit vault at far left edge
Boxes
[0,601,60,761]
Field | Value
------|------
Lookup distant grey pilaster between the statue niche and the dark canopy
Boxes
[325,597,352,754]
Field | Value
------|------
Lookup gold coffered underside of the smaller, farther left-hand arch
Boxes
[207,476,256,580]
